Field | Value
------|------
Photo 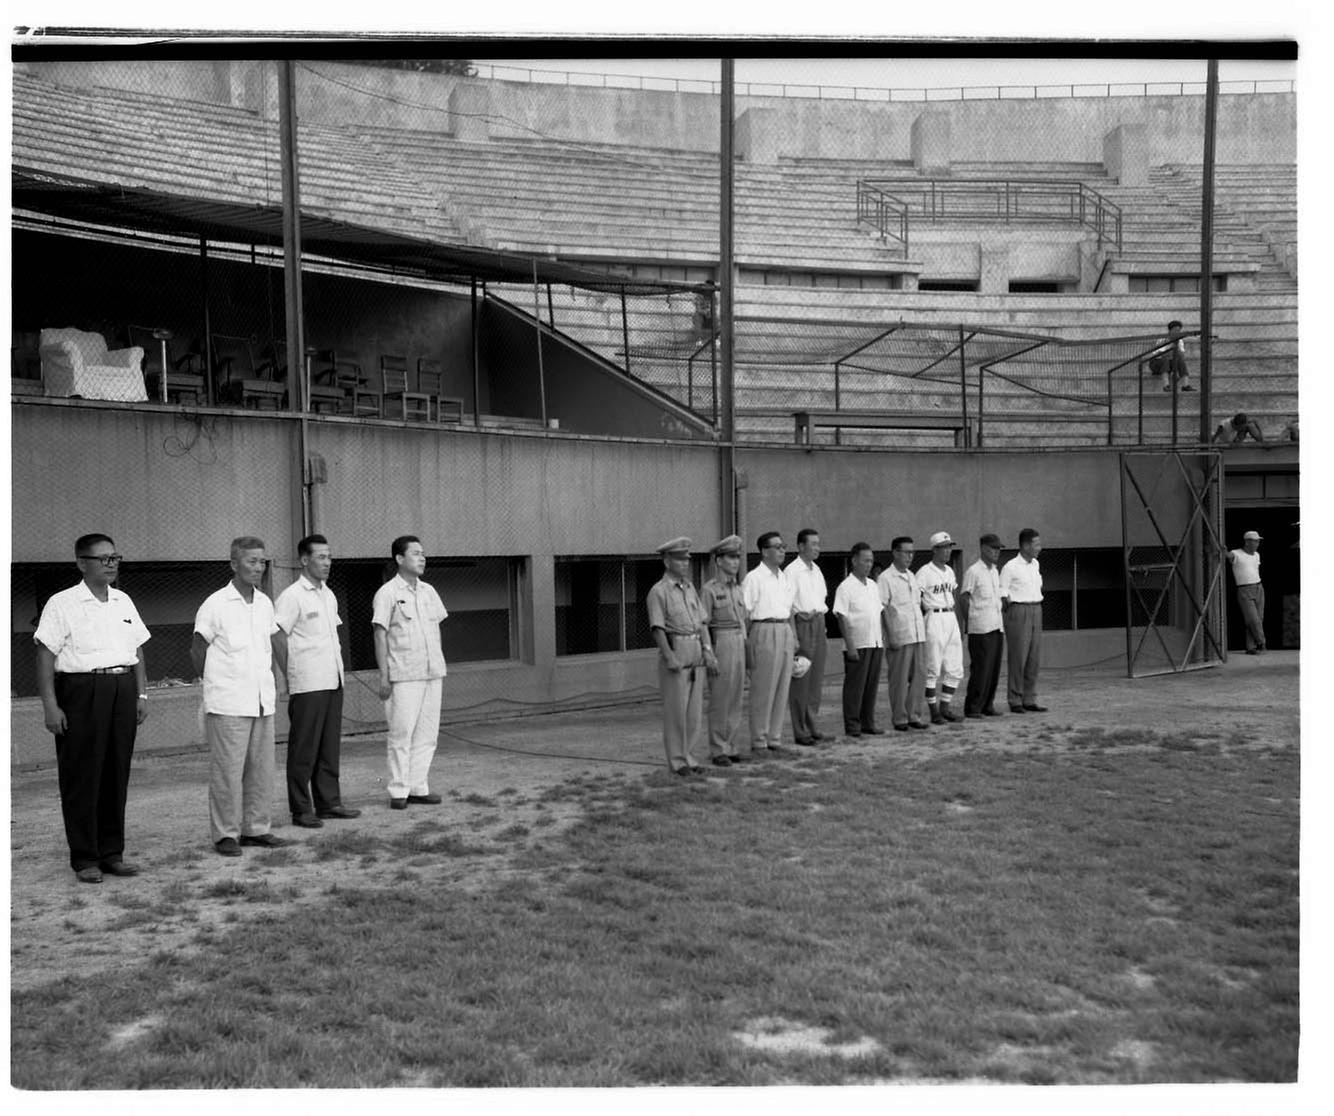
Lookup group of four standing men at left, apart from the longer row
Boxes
[33,533,448,883]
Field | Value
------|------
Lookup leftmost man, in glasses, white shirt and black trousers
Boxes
[33,535,149,884]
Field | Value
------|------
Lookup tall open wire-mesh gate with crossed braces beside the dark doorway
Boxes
[1121,449,1227,679]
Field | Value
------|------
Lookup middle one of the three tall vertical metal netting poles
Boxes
[718,59,736,535]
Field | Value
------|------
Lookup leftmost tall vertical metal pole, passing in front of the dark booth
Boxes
[277,60,311,537]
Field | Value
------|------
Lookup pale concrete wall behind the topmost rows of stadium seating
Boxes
[18,61,1297,164]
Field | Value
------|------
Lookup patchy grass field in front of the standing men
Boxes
[11,725,1299,1089]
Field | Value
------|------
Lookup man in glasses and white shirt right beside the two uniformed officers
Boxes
[742,531,796,756]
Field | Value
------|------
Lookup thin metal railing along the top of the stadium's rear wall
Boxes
[476,63,1297,103]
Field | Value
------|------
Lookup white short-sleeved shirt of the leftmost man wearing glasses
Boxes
[32,581,149,675]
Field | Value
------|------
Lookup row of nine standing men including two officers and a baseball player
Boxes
[646,528,1046,776]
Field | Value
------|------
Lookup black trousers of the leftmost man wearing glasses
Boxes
[56,671,139,872]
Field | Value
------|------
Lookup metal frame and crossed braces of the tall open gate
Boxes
[1119,449,1227,679]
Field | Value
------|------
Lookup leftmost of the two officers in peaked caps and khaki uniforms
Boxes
[646,536,718,775]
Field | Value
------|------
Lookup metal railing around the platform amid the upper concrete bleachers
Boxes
[856,179,1122,251]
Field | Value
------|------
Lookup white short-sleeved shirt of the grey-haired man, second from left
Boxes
[195,581,277,717]
